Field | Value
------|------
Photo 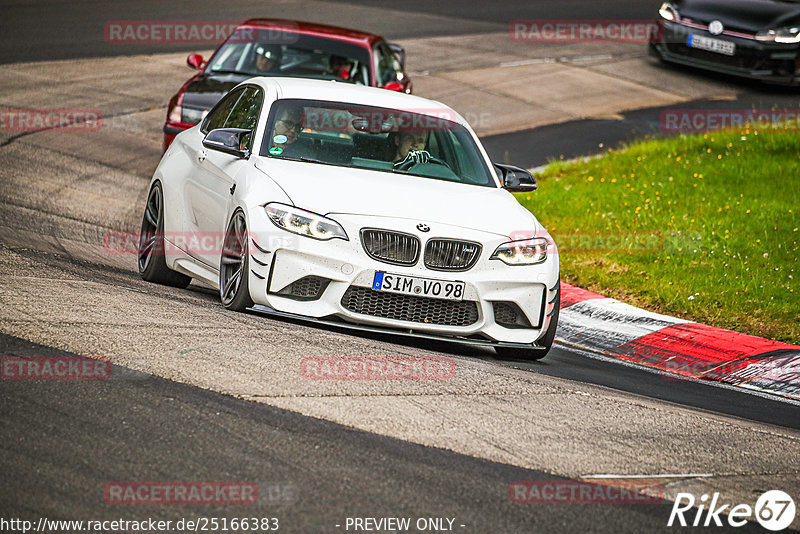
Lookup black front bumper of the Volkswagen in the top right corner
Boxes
[649,20,800,85]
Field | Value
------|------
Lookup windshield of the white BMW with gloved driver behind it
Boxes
[261,100,497,187]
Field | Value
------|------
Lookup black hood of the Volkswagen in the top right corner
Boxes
[675,0,800,33]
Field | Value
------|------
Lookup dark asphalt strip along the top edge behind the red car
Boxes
[0,0,659,63]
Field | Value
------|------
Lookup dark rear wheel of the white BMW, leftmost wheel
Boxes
[137,182,192,289]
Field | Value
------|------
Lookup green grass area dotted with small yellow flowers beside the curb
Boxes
[518,130,800,343]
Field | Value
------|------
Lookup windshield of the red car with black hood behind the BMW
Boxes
[205,28,370,85]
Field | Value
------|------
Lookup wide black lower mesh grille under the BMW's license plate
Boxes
[342,286,478,326]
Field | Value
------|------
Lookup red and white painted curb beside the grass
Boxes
[556,282,800,400]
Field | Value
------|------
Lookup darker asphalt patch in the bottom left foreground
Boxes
[0,336,780,533]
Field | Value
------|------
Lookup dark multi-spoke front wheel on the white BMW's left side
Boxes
[219,210,253,311]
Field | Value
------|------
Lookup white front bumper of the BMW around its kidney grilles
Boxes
[248,206,558,348]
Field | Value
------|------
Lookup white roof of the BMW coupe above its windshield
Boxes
[243,76,469,126]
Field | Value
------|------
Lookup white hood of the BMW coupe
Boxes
[255,157,543,236]
